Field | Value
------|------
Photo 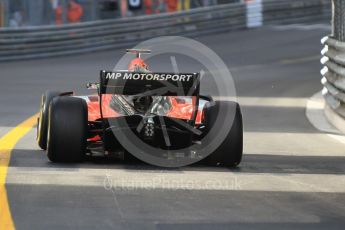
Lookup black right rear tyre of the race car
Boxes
[204,101,243,167]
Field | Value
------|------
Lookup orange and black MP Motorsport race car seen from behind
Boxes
[37,50,243,167]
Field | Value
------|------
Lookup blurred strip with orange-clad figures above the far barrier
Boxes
[0,0,240,27]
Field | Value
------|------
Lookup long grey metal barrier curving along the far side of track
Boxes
[0,0,330,61]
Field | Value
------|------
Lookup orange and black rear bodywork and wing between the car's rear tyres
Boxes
[87,71,205,153]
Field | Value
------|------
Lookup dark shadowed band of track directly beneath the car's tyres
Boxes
[10,149,345,174]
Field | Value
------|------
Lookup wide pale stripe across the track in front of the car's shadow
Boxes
[7,167,345,193]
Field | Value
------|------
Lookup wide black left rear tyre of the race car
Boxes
[47,96,88,162]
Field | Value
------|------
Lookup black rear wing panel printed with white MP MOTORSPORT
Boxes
[100,71,200,96]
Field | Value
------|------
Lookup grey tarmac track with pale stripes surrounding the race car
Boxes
[0,26,345,229]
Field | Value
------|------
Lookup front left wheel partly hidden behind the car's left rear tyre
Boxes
[36,91,60,150]
